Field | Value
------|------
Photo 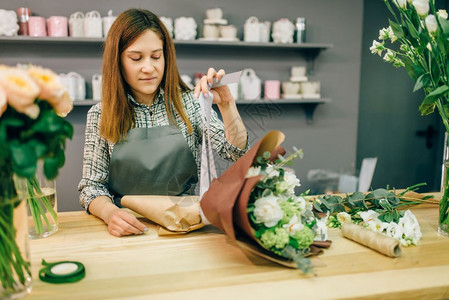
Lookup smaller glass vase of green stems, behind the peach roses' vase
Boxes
[26,161,58,239]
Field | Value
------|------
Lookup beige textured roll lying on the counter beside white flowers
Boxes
[341,223,401,257]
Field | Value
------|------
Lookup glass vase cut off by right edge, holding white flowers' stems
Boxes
[438,132,449,237]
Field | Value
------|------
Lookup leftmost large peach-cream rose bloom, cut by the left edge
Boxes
[0,67,40,119]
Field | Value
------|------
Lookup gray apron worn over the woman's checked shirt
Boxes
[109,125,198,207]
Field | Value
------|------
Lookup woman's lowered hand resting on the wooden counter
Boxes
[104,208,148,236]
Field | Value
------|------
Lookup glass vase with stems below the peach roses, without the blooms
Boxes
[0,169,32,299]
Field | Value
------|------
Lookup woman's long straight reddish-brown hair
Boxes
[100,9,193,143]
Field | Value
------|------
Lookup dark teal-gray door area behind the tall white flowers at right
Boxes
[357,0,448,191]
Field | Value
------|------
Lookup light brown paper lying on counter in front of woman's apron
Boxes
[121,195,204,235]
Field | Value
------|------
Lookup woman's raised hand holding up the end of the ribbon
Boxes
[194,68,235,106]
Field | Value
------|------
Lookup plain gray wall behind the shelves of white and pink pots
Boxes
[0,0,363,210]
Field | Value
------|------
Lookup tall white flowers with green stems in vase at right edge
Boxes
[370,0,449,236]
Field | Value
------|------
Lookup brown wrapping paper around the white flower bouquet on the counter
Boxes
[201,131,331,268]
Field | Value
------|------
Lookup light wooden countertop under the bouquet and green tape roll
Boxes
[27,205,449,300]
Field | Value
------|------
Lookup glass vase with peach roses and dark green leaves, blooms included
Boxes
[0,65,73,299]
